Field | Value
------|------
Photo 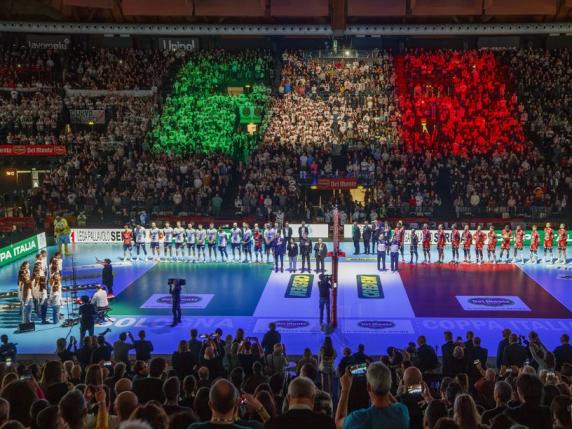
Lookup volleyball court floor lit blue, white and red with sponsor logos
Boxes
[0,243,572,355]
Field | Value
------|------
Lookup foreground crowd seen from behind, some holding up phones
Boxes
[0,324,572,429]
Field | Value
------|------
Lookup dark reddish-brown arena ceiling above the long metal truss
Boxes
[0,0,572,29]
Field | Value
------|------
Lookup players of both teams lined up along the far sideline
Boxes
[117,221,567,265]
